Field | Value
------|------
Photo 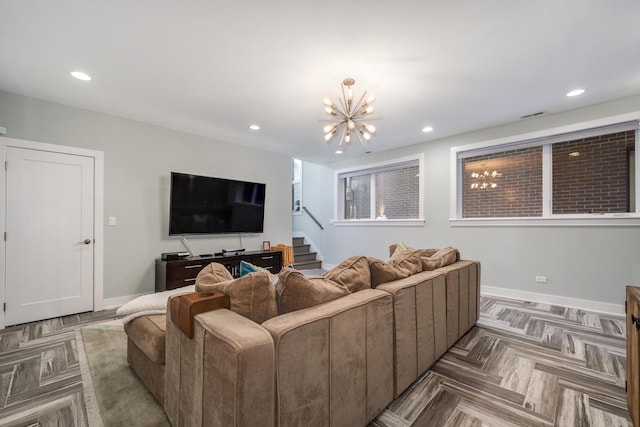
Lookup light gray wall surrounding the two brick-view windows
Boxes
[294,96,640,304]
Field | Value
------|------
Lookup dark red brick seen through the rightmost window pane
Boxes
[552,131,635,214]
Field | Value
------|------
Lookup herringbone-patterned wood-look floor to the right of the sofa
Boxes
[371,297,632,427]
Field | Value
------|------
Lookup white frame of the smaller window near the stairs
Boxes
[331,153,426,227]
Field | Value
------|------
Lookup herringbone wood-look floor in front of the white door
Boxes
[0,310,116,427]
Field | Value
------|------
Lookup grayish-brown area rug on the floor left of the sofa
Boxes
[76,320,171,427]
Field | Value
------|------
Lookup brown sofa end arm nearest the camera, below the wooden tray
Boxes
[164,301,275,427]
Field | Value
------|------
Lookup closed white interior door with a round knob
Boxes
[5,147,94,326]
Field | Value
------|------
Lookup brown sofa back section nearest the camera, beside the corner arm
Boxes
[262,289,393,426]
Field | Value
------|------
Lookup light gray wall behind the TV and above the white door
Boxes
[0,91,291,298]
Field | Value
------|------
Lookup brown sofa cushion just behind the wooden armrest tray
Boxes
[196,274,278,323]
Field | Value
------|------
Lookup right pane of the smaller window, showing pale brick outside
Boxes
[375,165,420,219]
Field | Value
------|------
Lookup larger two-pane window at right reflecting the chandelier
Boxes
[452,116,640,221]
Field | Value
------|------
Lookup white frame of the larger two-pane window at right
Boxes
[449,111,640,227]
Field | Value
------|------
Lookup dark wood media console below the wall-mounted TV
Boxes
[156,251,282,292]
